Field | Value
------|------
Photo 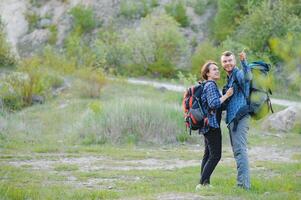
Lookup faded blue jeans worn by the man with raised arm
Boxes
[228,116,251,189]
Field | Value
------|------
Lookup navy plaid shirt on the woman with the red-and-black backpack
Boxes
[200,81,221,134]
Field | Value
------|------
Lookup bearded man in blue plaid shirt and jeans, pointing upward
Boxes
[221,51,251,190]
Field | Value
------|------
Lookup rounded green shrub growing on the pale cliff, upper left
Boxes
[70,5,97,33]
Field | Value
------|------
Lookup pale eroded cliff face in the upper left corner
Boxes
[0,0,119,56]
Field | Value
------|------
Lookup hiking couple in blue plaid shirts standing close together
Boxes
[196,51,251,190]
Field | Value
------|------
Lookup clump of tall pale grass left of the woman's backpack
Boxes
[79,96,184,144]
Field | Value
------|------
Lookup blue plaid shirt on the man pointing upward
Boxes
[226,61,252,124]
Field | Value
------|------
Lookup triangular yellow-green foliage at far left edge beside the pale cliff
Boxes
[0,17,16,67]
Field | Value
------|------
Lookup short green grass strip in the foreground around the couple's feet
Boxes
[0,159,301,199]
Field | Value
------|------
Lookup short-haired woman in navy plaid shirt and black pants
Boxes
[196,61,233,190]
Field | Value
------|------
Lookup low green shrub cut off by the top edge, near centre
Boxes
[119,0,158,19]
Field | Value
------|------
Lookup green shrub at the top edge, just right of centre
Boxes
[165,0,190,27]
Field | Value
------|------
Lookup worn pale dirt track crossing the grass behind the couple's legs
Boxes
[0,147,300,200]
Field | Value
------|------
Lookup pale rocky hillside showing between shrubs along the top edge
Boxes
[0,0,214,57]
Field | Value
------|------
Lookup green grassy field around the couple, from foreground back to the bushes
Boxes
[0,77,301,199]
